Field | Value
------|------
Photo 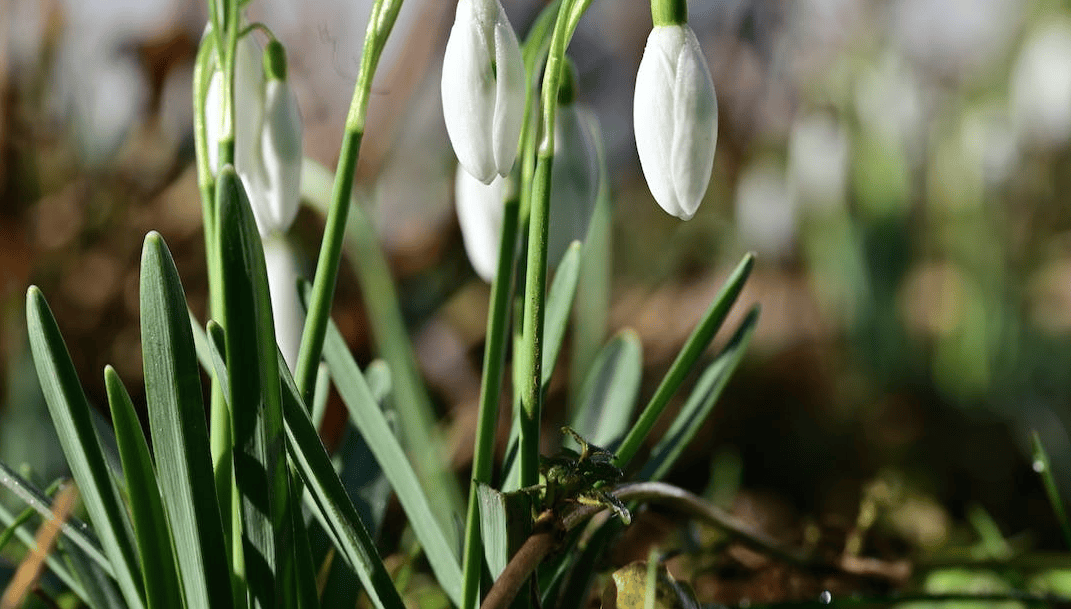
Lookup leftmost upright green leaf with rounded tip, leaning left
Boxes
[26,286,145,608]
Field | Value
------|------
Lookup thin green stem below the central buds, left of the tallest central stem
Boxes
[462,197,521,609]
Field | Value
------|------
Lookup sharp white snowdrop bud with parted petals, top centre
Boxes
[442,0,525,184]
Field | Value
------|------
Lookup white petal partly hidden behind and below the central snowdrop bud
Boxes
[454,167,506,283]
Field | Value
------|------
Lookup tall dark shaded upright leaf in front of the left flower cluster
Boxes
[216,167,293,607]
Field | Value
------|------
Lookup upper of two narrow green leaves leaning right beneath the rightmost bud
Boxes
[615,254,755,470]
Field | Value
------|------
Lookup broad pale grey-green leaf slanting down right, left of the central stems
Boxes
[323,322,462,605]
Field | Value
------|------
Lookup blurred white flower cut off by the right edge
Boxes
[1011,19,1071,147]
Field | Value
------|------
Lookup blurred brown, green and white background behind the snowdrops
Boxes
[0,0,1071,582]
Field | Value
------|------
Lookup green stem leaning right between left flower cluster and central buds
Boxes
[295,0,402,404]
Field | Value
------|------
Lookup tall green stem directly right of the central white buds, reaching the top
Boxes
[519,0,591,487]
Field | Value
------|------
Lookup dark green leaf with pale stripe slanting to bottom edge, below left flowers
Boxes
[276,351,405,609]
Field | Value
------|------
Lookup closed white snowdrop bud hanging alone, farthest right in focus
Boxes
[633,24,718,219]
